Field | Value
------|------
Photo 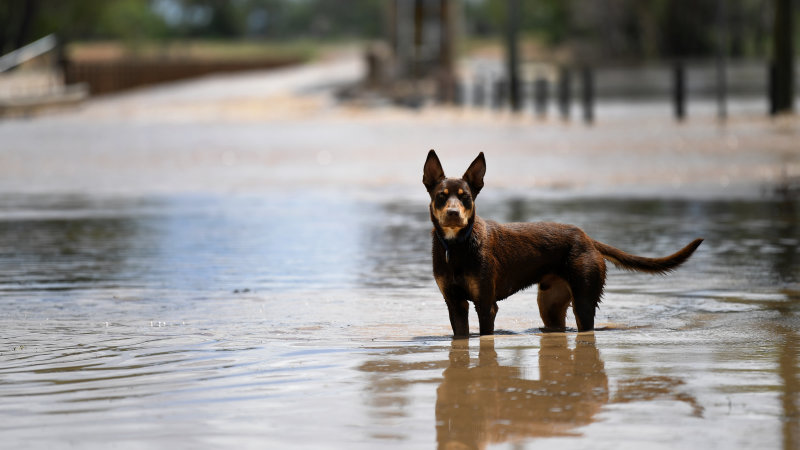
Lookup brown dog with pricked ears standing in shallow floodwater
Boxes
[422,150,703,337]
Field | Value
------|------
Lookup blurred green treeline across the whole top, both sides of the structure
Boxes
[0,0,800,59]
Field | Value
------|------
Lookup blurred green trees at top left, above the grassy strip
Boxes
[0,0,387,51]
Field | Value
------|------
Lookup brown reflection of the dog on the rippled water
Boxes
[436,333,702,448]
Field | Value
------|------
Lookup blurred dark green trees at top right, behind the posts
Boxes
[464,0,788,59]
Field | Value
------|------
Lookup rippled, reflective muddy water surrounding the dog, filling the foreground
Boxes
[0,192,800,449]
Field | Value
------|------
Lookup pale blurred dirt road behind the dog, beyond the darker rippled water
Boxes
[0,54,800,196]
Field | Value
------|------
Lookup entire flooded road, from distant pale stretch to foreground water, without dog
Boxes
[0,54,800,449]
